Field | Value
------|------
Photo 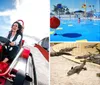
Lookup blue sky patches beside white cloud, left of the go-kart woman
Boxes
[0,0,15,36]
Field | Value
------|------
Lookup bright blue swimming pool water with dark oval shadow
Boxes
[50,19,100,41]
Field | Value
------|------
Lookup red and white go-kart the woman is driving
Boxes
[0,36,38,85]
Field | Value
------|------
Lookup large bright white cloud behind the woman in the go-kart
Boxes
[0,0,50,39]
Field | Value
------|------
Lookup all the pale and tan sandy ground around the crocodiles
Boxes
[50,43,100,85]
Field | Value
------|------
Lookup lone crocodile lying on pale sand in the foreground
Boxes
[67,60,87,76]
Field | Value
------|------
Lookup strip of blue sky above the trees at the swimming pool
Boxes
[50,0,100,11]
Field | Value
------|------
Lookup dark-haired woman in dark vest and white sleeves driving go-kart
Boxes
[0,22,22,72]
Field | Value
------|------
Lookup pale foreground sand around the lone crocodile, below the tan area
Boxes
[50,56,100,85]
